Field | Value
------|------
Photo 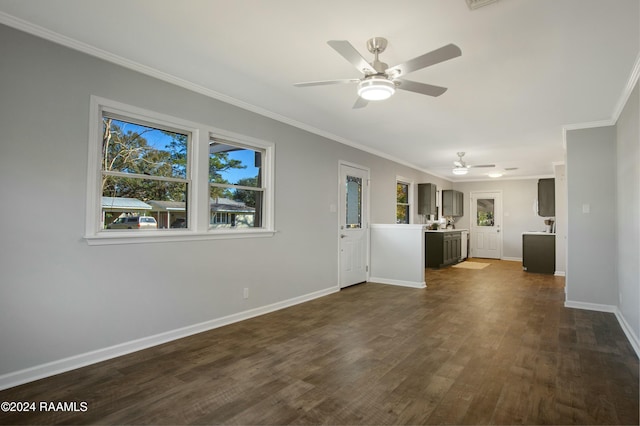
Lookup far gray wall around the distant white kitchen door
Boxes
[454,179,545,260]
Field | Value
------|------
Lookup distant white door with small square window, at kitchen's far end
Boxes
[470,192,502,259]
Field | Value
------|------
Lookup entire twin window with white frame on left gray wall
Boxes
[85,97,275,244]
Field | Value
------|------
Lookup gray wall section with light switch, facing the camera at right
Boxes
[566,126,618,305]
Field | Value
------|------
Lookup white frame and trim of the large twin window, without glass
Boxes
[84,96,275,245]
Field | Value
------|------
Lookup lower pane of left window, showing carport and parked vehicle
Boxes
[102,176,188,229]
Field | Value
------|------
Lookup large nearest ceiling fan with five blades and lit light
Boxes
[294,37,462,108]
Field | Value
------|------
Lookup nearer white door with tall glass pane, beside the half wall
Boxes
[339,163,369,288]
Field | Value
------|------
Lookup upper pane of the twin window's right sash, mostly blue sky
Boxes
[209,141,263,188]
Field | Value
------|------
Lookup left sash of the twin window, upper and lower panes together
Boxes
[100,115,191,232]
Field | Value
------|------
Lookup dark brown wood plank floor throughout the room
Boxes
[0,259,639,425]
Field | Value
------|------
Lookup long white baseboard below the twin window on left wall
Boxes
[0,287,340,390]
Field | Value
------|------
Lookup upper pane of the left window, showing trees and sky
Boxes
[102,116,189,179]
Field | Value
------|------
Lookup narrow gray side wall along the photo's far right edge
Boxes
[616,82,640,341]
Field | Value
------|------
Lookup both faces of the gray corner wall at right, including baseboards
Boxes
[566,81,640,351]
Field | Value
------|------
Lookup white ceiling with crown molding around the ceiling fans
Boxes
[0,0,640,181]
